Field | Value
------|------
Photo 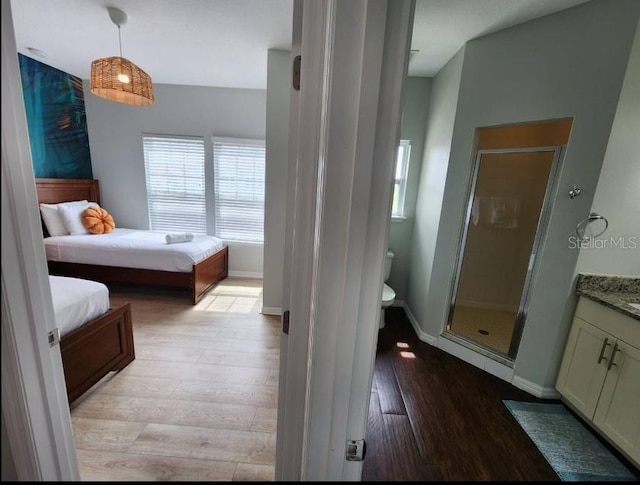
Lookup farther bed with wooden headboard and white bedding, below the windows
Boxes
[36,178,229,305]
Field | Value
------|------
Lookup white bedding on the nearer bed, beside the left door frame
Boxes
[49,275,109,337]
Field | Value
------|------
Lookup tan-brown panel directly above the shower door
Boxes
[476,118,573,150]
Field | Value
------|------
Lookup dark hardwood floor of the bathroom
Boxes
[362,308,559,481]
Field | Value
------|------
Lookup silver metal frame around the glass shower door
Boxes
[443,145,566,362]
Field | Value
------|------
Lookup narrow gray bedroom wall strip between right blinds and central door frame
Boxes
[262,49,291,312]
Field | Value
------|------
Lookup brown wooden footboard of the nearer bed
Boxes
[60,303,135,404]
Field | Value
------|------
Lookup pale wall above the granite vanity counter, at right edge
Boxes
[578,23,640,276]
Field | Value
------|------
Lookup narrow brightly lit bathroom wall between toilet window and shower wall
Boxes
[406,47,464,322]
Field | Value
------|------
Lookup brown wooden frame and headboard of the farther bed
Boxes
[36,178,229,305]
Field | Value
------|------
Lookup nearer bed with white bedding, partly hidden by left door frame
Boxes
[49,275,135,404]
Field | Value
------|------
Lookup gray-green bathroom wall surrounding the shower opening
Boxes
[408,0,640,389]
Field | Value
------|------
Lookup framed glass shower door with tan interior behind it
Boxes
[447,147,560,358]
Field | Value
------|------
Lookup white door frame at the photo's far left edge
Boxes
[0,0,80,481]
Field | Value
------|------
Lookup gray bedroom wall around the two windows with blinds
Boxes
[85,82,266,274]
